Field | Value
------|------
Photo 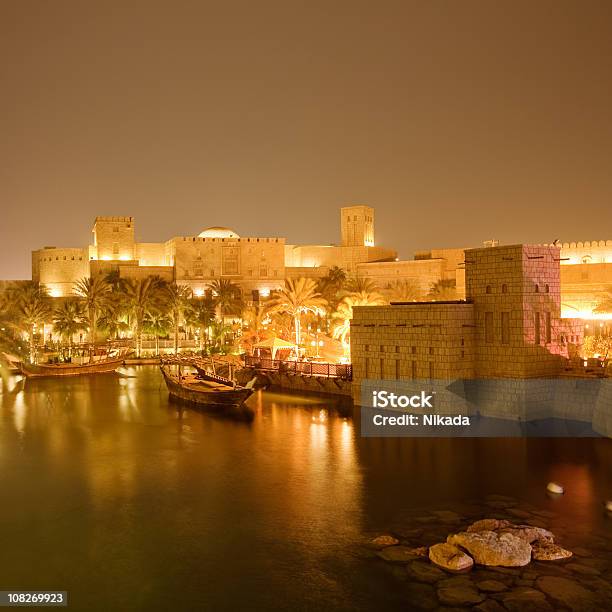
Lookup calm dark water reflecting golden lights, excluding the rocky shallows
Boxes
[0,367,612,610]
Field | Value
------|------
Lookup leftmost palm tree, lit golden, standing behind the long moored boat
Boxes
[8,281,51,363]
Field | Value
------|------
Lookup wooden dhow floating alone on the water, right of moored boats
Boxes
[160,356,255,420]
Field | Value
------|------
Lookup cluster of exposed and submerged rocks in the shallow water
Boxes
[369,496,612,612]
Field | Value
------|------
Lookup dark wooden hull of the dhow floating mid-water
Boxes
[161,368,253,420]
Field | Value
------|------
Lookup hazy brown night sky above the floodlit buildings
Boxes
[0,0,612,279]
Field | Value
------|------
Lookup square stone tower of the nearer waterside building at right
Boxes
[465,244,562,378]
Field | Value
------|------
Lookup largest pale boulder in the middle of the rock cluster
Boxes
[446,531,531,567]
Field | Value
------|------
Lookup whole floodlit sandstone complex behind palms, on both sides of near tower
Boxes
[32,205,612,326]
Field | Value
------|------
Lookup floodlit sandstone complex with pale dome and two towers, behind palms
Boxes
[32,205,397,297]
